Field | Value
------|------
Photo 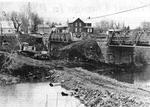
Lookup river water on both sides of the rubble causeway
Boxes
[0,65,150,107]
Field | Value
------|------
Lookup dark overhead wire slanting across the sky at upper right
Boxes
[88,4,150,19]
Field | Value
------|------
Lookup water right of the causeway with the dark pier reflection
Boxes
[107,65,150,91]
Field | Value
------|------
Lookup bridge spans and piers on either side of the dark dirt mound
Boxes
[49,30,150,65]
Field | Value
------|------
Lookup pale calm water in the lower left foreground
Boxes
[0,82,84,107]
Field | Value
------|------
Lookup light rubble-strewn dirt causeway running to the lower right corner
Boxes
[52,68,150,107]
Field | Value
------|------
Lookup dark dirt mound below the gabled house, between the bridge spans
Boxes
[59,39,103,62]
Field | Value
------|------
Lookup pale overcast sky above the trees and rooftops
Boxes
[0,0,150,28]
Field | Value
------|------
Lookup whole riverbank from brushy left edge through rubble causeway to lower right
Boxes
[1,51,150,107]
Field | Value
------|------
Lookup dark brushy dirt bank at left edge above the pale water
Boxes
[0,53,53,83]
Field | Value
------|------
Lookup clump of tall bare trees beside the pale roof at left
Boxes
[10,12,43,33]
